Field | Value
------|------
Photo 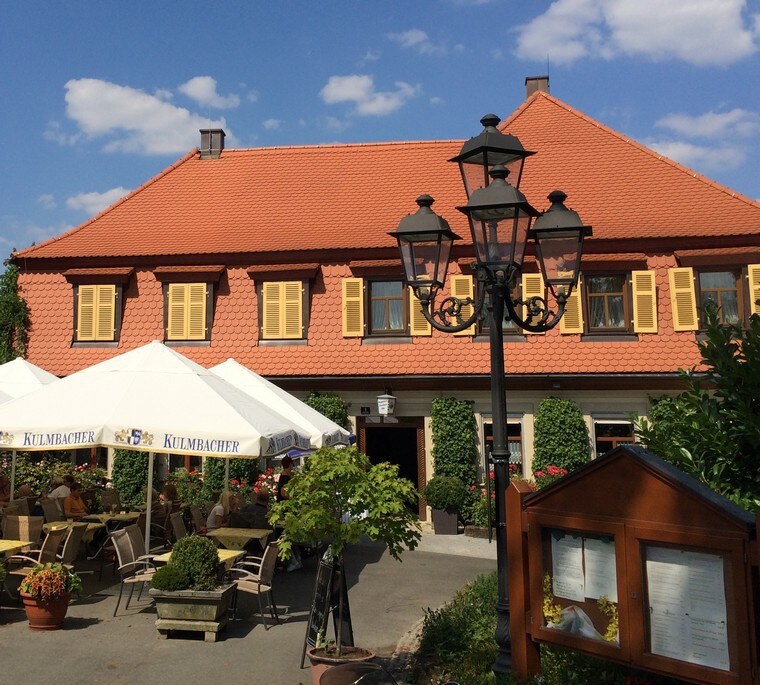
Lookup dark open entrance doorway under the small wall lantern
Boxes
[357,417,427,521]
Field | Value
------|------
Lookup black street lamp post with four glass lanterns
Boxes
[390,114,591,673]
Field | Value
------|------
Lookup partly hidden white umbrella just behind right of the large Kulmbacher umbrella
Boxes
[209,359,350,449]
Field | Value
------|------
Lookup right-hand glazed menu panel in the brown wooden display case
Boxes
[645,545,730,671]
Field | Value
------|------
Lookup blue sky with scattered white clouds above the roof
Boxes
[0,0,760,256]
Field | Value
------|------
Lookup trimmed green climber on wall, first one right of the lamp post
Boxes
[533,397,591,471]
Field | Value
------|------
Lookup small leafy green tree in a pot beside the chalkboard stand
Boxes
[269,447,420,683]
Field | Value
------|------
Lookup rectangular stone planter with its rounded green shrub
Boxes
[150,535,235,642]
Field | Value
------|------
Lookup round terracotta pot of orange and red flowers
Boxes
[19,563,82,630]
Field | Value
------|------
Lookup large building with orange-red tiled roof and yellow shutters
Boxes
[13,76,760,512]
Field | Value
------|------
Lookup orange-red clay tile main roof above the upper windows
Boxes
[17,92,760,259]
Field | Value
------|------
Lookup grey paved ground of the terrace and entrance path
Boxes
[0,533,496,685]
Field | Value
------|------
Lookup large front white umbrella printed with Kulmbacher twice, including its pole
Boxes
[0,342,309,530]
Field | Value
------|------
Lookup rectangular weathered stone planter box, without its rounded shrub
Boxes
[150,583,235,642]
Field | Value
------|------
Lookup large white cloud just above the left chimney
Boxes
[63,78,234,155]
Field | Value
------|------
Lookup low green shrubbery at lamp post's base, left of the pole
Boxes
[419,572,498,685]
